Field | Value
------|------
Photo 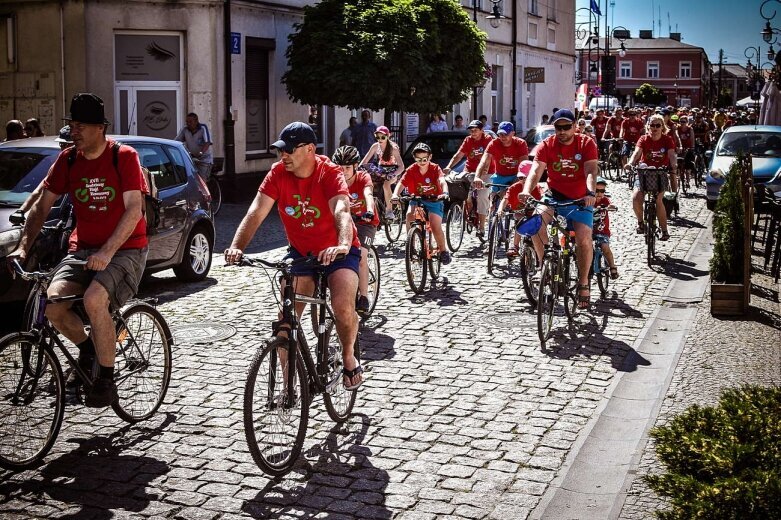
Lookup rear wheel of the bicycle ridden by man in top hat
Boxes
[111,302,173,423]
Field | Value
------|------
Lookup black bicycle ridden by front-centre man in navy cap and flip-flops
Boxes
[239,256,360,476]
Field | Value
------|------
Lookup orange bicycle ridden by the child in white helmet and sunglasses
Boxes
[399,195,442,294]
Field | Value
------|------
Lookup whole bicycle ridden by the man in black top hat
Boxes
[0,260,174,471]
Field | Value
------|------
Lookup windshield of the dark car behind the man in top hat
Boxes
[0,149,59,206]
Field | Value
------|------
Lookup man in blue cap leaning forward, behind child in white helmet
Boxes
[474,121,529,238]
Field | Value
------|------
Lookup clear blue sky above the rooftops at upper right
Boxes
[575,0,781,65]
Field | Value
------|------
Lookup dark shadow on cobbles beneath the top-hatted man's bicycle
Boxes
[0,413,176,519]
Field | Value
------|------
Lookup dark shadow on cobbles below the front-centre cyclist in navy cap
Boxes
[241,414,393,519]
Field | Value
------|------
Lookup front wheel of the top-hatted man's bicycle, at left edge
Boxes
[0,333,65,471]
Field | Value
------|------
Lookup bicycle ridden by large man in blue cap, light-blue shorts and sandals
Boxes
[529,199,583,349]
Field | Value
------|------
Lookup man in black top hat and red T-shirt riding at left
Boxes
[10,94,148,407]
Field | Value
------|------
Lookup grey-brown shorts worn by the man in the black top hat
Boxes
[52,247,148,310]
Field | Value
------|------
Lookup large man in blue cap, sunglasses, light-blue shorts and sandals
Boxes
[521,109,599,309]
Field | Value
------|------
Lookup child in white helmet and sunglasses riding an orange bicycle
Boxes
[391,143,450,265]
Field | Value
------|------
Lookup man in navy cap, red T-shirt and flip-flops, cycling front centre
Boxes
[225,121,363,390]
